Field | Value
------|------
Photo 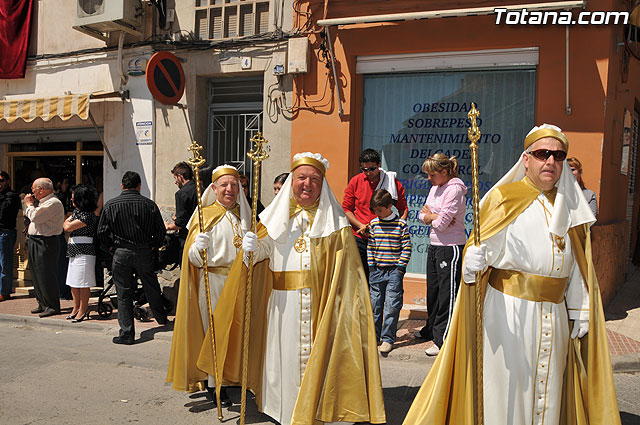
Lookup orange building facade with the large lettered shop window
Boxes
[291,0,640,304]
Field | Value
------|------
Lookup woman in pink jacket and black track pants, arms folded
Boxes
[414,153,467,356]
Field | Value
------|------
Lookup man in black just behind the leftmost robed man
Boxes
[166,161,198,258]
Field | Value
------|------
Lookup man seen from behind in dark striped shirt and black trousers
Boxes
[98,171,167,345]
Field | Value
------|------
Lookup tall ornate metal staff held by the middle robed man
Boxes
[240,132,269,425]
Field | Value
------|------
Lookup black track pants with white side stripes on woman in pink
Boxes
[420,245,464,347]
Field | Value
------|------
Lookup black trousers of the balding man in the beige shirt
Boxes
[27,236,60,312]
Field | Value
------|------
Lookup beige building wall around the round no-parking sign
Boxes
[0,0,293,209]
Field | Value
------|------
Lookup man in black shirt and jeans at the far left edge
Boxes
[0,171,20,301]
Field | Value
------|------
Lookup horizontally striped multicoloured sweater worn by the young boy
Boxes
[367,214,411,268]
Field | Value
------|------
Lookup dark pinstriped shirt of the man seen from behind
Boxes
[97,189,166,248]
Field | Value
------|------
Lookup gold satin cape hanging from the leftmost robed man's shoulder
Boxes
[167,202,226,392]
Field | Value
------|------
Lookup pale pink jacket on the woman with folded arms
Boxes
[425,177,467,246]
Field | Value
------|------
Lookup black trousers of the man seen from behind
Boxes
[112,248,167,341]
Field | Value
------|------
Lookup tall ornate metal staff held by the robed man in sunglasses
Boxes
[467,103,484,425]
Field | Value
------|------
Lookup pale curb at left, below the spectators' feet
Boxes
[0,313,173,342]
